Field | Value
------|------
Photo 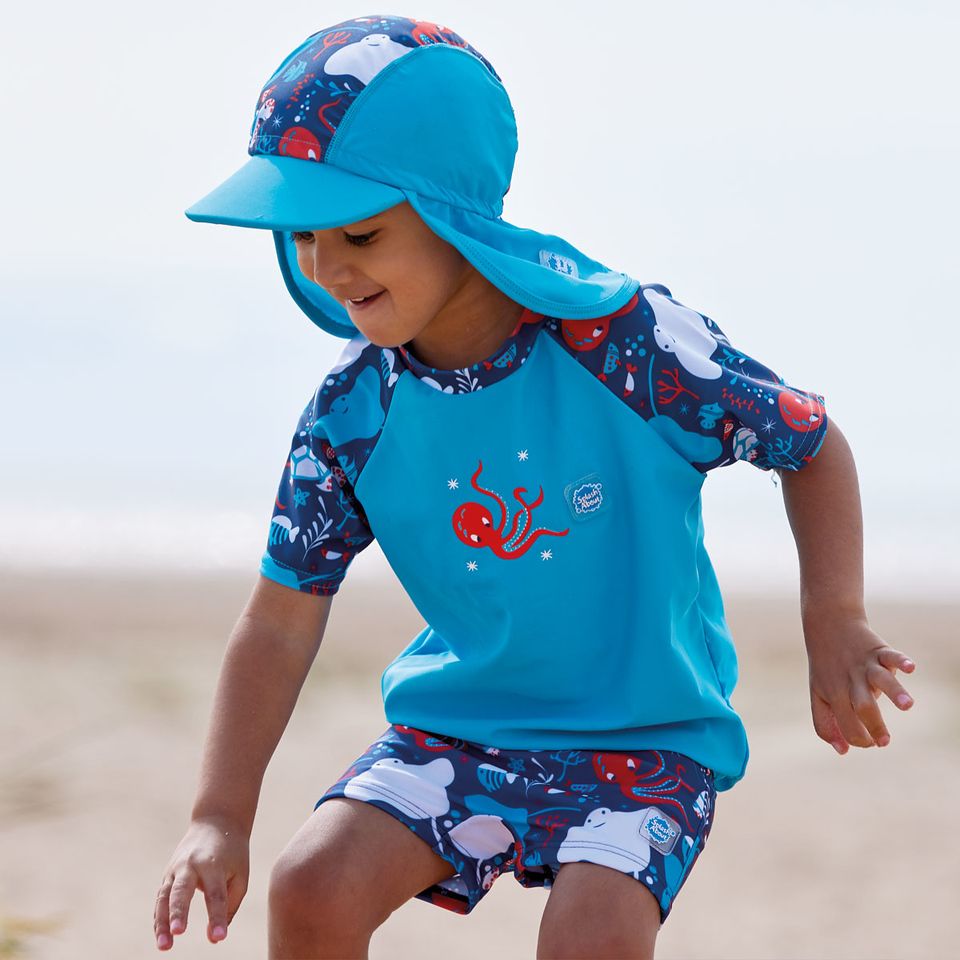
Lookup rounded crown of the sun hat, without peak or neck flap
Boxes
[247,16,517,217]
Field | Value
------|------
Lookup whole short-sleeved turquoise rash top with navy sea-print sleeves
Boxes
[261,284,827,791]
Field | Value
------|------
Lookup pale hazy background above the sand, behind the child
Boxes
[0,0,960,593]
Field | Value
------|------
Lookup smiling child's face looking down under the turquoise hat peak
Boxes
[293,202,479,347]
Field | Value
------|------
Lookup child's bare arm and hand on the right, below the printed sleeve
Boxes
[777,421,915,754]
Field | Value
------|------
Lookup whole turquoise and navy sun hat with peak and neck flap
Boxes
[186,16,639,337]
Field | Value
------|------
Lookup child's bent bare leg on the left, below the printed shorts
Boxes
[269,797,455,960]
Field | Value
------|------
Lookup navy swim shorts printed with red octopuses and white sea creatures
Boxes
[316,725,716,923]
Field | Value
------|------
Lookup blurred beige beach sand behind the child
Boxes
[0,575,960,960]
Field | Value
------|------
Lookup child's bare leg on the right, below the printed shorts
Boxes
[537,863,660,960]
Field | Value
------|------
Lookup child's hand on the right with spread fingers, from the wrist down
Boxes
[804,618,916,755]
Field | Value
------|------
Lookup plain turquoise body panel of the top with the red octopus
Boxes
[318,336,748,790]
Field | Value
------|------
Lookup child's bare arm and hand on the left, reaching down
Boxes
[154,576,333,950]
